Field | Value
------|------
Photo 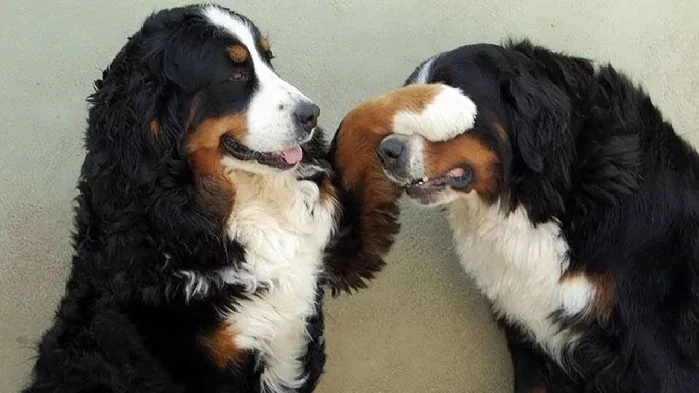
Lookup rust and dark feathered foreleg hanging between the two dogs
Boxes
[326,121,401,295]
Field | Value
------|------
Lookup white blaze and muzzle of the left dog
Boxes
[203,5,311,152]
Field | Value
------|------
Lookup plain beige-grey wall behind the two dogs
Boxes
[0,0,699,393]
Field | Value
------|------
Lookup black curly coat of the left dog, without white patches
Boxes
[24,6,388,393]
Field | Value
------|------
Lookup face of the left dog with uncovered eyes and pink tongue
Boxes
[182,6,320,173]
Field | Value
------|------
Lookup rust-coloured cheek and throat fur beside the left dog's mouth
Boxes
[187,114,247,221]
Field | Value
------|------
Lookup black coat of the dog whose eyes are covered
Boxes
[407,41,699,393]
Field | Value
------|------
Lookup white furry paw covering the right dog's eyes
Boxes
[393,85,477,142]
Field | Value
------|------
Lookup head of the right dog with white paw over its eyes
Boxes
[343,45,574,220]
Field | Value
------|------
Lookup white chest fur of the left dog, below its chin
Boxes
[223,175,335,393]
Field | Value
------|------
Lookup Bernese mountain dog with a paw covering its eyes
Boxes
[337,41,699,393]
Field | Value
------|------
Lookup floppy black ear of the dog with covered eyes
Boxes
[501,64,573,173]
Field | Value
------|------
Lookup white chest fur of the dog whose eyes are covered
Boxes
[449,195,593,359]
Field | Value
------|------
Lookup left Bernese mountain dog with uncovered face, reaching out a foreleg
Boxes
[24,5,398,393]
